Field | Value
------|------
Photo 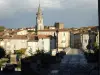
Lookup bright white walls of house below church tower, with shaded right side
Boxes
[26,38,55,55]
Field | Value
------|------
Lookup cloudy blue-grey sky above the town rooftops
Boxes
[0,0,98,28]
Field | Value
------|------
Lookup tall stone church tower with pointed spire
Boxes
[36,3,44,31]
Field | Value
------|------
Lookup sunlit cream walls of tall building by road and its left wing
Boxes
[38,31,70,47]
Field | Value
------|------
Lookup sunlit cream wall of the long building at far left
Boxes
[0,39,27,53]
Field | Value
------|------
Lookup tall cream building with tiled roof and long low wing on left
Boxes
[38,29,70,48]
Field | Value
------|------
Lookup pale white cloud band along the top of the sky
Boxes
[0,0,98,18]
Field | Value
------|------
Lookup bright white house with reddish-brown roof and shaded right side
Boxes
[25,35,56,55]
